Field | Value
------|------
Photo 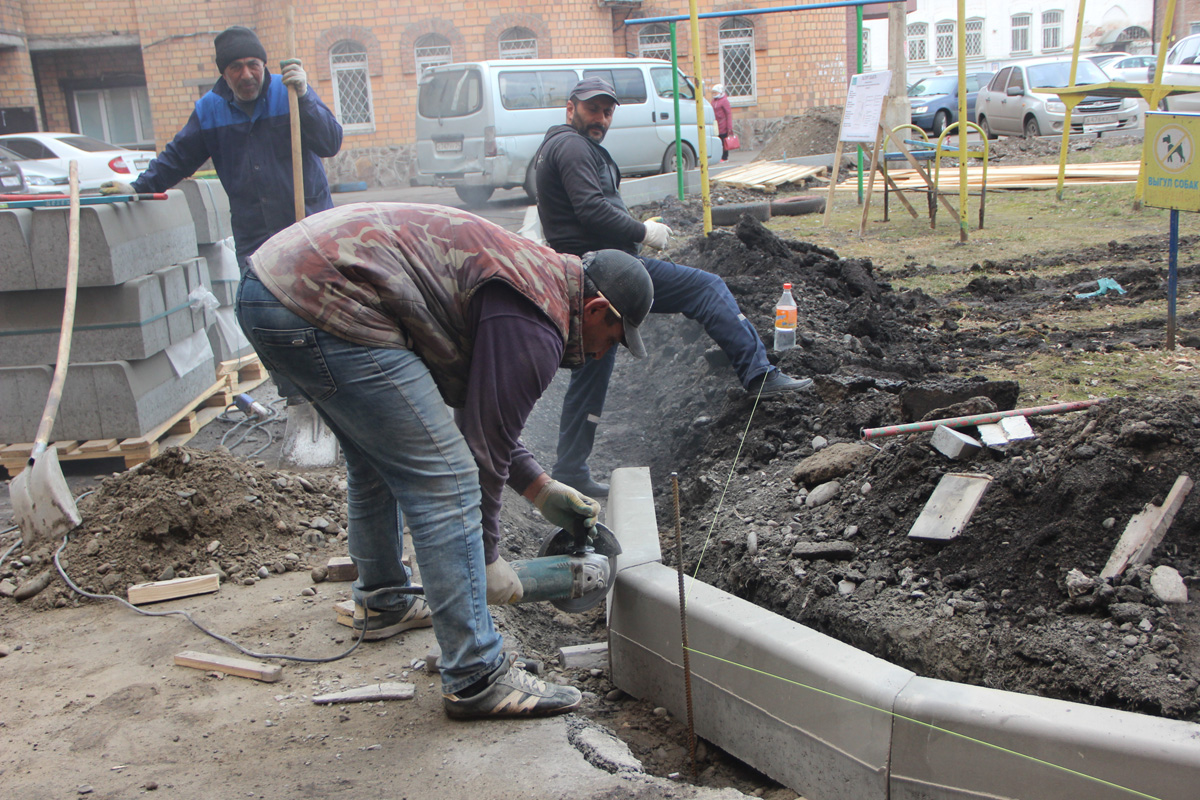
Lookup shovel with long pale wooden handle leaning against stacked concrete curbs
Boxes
[8,161,83,549]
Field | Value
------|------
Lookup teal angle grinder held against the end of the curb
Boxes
[509,523,620,614]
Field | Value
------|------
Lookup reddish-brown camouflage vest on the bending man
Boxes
[251,203,583,408]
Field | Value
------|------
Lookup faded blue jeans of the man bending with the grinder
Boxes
[236,273,504,692]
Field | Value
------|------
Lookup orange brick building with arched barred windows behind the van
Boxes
[0,0,853,185]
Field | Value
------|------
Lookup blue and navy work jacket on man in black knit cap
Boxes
[133,72,342,270]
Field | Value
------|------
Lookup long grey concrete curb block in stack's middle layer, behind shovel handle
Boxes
[0,275,170,367]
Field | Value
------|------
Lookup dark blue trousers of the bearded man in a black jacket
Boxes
[553,258,772,482]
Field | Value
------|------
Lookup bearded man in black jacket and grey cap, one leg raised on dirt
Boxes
[536,78,812,497]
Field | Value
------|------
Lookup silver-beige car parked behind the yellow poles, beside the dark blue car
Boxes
[976,59,1140,139]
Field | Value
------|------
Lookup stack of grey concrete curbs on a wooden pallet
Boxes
[0,181,252,443]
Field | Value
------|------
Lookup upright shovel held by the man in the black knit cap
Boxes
[280,5,337,469]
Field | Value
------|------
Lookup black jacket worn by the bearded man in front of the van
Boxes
[536,125,646,255]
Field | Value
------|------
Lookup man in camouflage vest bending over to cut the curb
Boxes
[238,203,653,718]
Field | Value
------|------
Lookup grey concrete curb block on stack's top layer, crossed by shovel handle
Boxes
[29,190,197,289]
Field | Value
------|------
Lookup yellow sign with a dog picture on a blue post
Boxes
[1141,112,1200,211]
